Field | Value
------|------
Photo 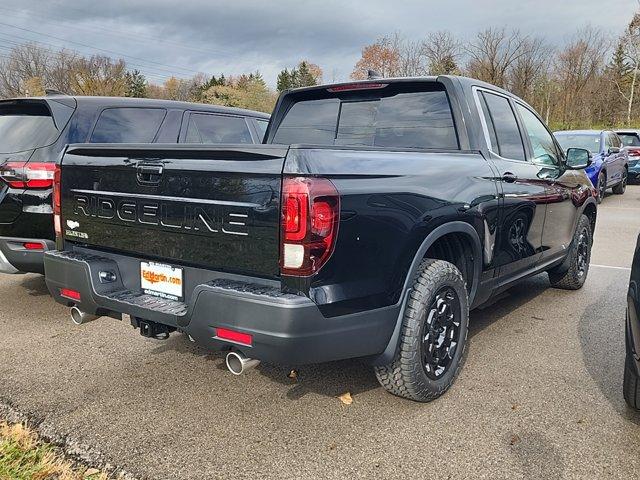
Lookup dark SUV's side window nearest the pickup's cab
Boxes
[185,113,253,144]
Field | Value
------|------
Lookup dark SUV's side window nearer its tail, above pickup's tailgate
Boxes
[90,108,167,143]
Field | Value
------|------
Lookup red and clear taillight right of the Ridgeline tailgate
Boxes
[280,177,340,276]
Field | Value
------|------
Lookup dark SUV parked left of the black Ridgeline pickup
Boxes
[0,95,269,273]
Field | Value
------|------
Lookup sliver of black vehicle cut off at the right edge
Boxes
[623,236,640,410]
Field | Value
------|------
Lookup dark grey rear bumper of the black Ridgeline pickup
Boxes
[45,251,399,365]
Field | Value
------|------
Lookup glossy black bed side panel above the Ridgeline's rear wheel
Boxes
[284,147,498,315]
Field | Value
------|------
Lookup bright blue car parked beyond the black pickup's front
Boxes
[554,130,629,203]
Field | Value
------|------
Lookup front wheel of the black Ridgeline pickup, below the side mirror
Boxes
[549,215,593,290]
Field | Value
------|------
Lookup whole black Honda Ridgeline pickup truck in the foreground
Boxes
[45,76,596,401]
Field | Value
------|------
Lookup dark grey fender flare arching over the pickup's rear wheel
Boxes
[370,221,483,365]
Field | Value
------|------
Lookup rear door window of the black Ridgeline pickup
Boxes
[482,92,525,160]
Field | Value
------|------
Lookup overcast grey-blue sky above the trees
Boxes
[0,0,638,86]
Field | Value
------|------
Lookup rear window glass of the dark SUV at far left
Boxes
[0,103,60,153]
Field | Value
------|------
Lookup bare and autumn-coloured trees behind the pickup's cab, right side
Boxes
[351,13,640,129]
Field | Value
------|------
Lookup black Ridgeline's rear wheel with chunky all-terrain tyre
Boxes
[375,259,469,402]
